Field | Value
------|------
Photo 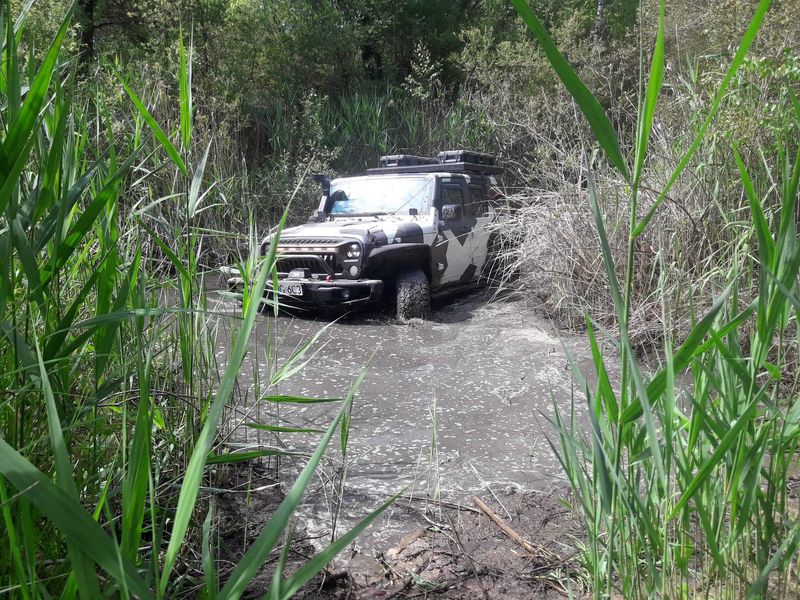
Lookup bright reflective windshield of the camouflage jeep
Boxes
[330,177,433,215]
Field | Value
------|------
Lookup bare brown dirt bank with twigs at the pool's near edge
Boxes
[217,464,582,600]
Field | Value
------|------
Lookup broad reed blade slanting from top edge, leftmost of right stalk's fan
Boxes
[511,0,630,180]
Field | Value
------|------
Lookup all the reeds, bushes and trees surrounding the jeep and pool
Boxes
[0,0,800,597]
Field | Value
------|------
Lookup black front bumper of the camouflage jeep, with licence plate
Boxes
[226,276,383,307]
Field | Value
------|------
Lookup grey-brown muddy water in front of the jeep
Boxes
[209,293,590,550]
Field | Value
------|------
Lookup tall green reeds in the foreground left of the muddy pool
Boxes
[0,1,391,599]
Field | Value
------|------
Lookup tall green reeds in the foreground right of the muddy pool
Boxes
[513,0,800,598]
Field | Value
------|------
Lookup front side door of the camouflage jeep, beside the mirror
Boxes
[431,177,475,288]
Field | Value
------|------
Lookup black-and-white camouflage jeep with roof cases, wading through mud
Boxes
[229,151,502,319]
